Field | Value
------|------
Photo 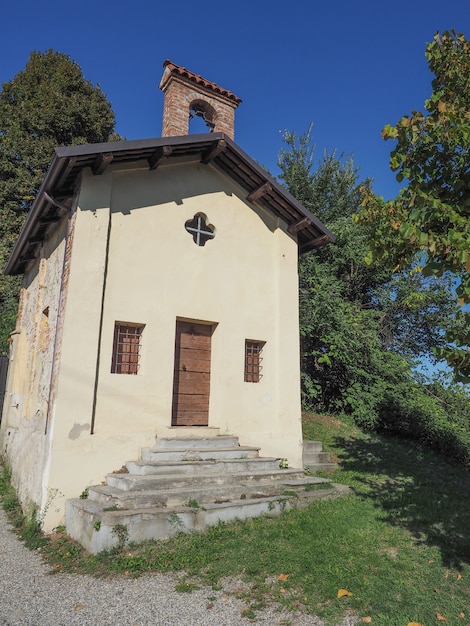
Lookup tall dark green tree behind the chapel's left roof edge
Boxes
[0,50,117,353]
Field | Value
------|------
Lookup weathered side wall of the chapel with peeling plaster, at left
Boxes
[0,218,67,508]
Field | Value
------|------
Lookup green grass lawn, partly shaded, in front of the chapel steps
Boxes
[0,415,470,626]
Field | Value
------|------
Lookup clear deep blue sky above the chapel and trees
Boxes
[0,0,470,198]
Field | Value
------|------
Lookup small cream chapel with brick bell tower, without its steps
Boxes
[0,61,334,531]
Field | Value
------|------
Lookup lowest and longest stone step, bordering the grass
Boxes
[66,478,346,554]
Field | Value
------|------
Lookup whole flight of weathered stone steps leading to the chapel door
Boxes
[66,437,348,553]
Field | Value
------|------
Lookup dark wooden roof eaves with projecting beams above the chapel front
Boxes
[4,133,335,274]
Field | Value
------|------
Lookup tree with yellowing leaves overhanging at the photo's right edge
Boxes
[357,31,470,382]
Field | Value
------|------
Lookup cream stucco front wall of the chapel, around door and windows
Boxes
[1,157,302,529]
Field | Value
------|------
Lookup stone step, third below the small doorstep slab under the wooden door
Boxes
[126,457,279,475]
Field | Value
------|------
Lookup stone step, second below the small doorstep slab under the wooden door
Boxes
[142,446,259,461]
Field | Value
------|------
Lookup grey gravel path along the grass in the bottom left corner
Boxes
[0,506,355,626]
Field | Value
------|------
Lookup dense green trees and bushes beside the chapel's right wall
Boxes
[279,129,470,465]
